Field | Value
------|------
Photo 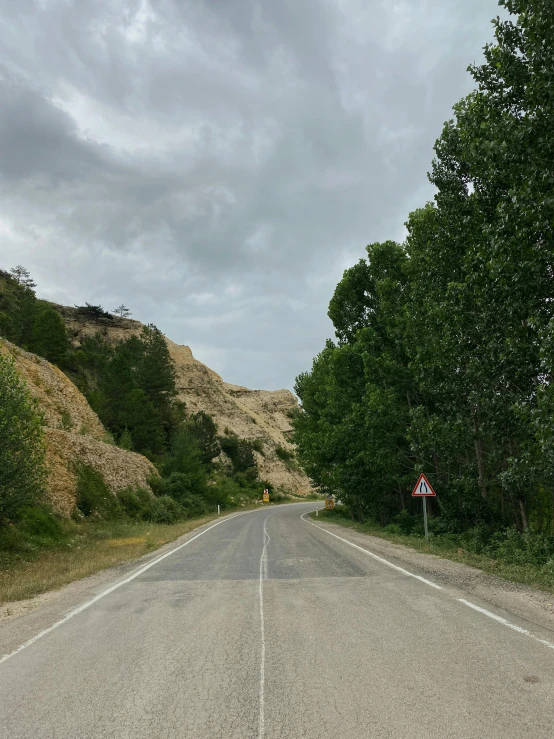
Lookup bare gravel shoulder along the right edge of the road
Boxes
[314,520,554,632]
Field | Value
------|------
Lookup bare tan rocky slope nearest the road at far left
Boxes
[0,338,157,515]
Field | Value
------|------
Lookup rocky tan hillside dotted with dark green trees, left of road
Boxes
[0,265,310,536]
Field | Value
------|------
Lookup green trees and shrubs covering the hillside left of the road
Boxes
[0,266,286,584]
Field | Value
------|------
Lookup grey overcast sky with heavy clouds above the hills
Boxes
[0,0,499,389]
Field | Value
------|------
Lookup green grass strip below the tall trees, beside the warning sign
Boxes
[311,510,554,593]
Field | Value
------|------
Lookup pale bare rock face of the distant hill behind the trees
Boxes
[54,305,311,495]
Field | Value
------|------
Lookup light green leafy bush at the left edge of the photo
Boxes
[0,354,45,527]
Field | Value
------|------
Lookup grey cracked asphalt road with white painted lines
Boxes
[0,503,554,739]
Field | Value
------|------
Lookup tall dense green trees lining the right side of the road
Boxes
[294,0,554,534]
